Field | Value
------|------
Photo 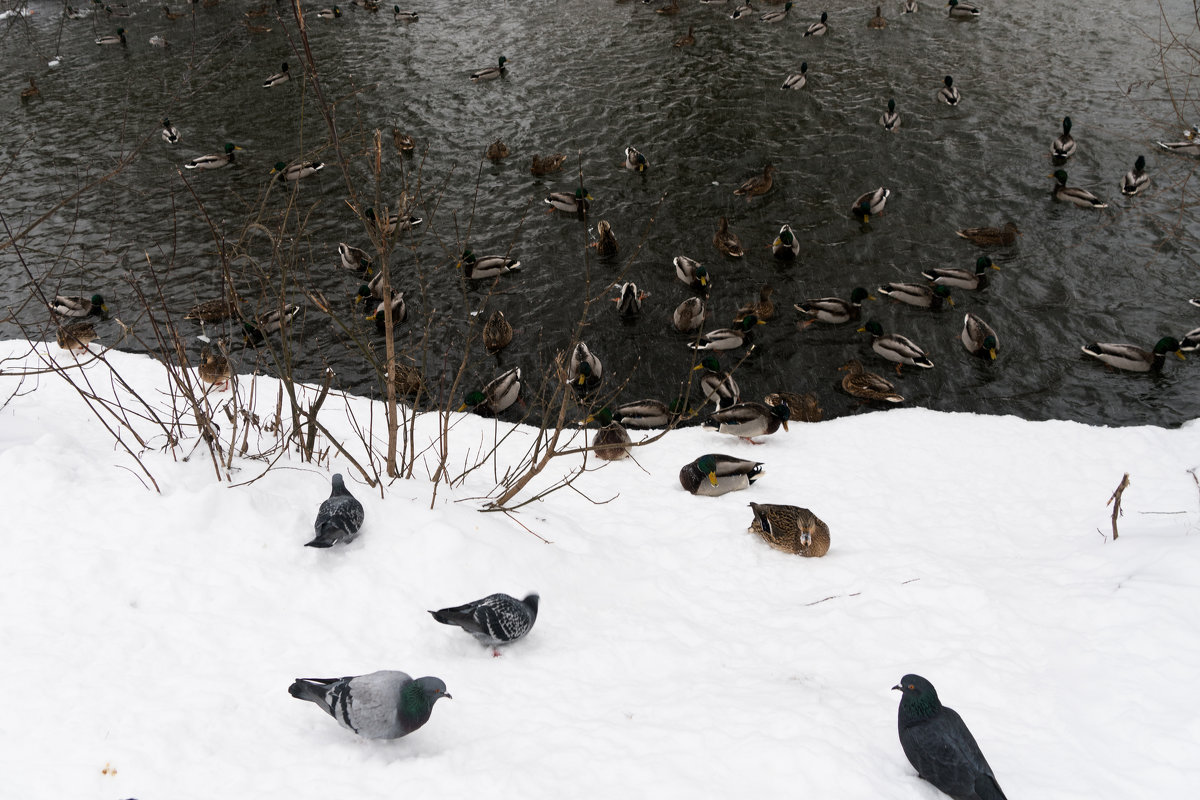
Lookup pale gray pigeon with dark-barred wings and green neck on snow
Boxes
[288,669,450,739]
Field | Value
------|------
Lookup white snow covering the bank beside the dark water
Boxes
[0,342,1200,800]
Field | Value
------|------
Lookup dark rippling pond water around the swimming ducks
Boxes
[7,0,1200,425]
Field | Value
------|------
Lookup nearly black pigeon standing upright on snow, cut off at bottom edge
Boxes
[892,675,1007,800]
